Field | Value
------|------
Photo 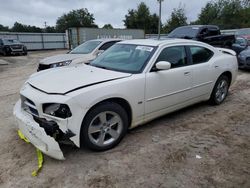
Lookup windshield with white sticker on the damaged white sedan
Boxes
[91,44,155,73]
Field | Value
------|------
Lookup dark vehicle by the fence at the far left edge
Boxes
[0,39,27,56]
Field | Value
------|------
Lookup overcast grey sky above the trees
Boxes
[0,0,209,28]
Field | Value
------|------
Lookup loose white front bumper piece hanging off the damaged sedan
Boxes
[14,100,65,160]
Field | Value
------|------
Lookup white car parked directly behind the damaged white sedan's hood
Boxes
[37,39,121,71]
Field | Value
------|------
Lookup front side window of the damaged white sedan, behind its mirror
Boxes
[156,46,187,68]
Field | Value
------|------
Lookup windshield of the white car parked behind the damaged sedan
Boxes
[70,41,101,54]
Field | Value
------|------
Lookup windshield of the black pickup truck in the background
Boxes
[168,27,199,38]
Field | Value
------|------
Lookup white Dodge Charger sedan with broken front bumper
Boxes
[14,39,238,159]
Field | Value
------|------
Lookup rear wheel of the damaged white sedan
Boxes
[209,75,230,105]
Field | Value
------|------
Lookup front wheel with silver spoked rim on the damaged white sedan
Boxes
[80,102,128,151]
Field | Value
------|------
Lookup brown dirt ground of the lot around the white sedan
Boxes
[0,51,250,188]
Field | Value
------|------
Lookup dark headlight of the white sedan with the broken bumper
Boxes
[43,103,72,119]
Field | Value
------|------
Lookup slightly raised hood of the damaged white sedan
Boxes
[27,65,131,94]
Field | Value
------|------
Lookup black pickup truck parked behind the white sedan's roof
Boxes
[168,25,235,48]
